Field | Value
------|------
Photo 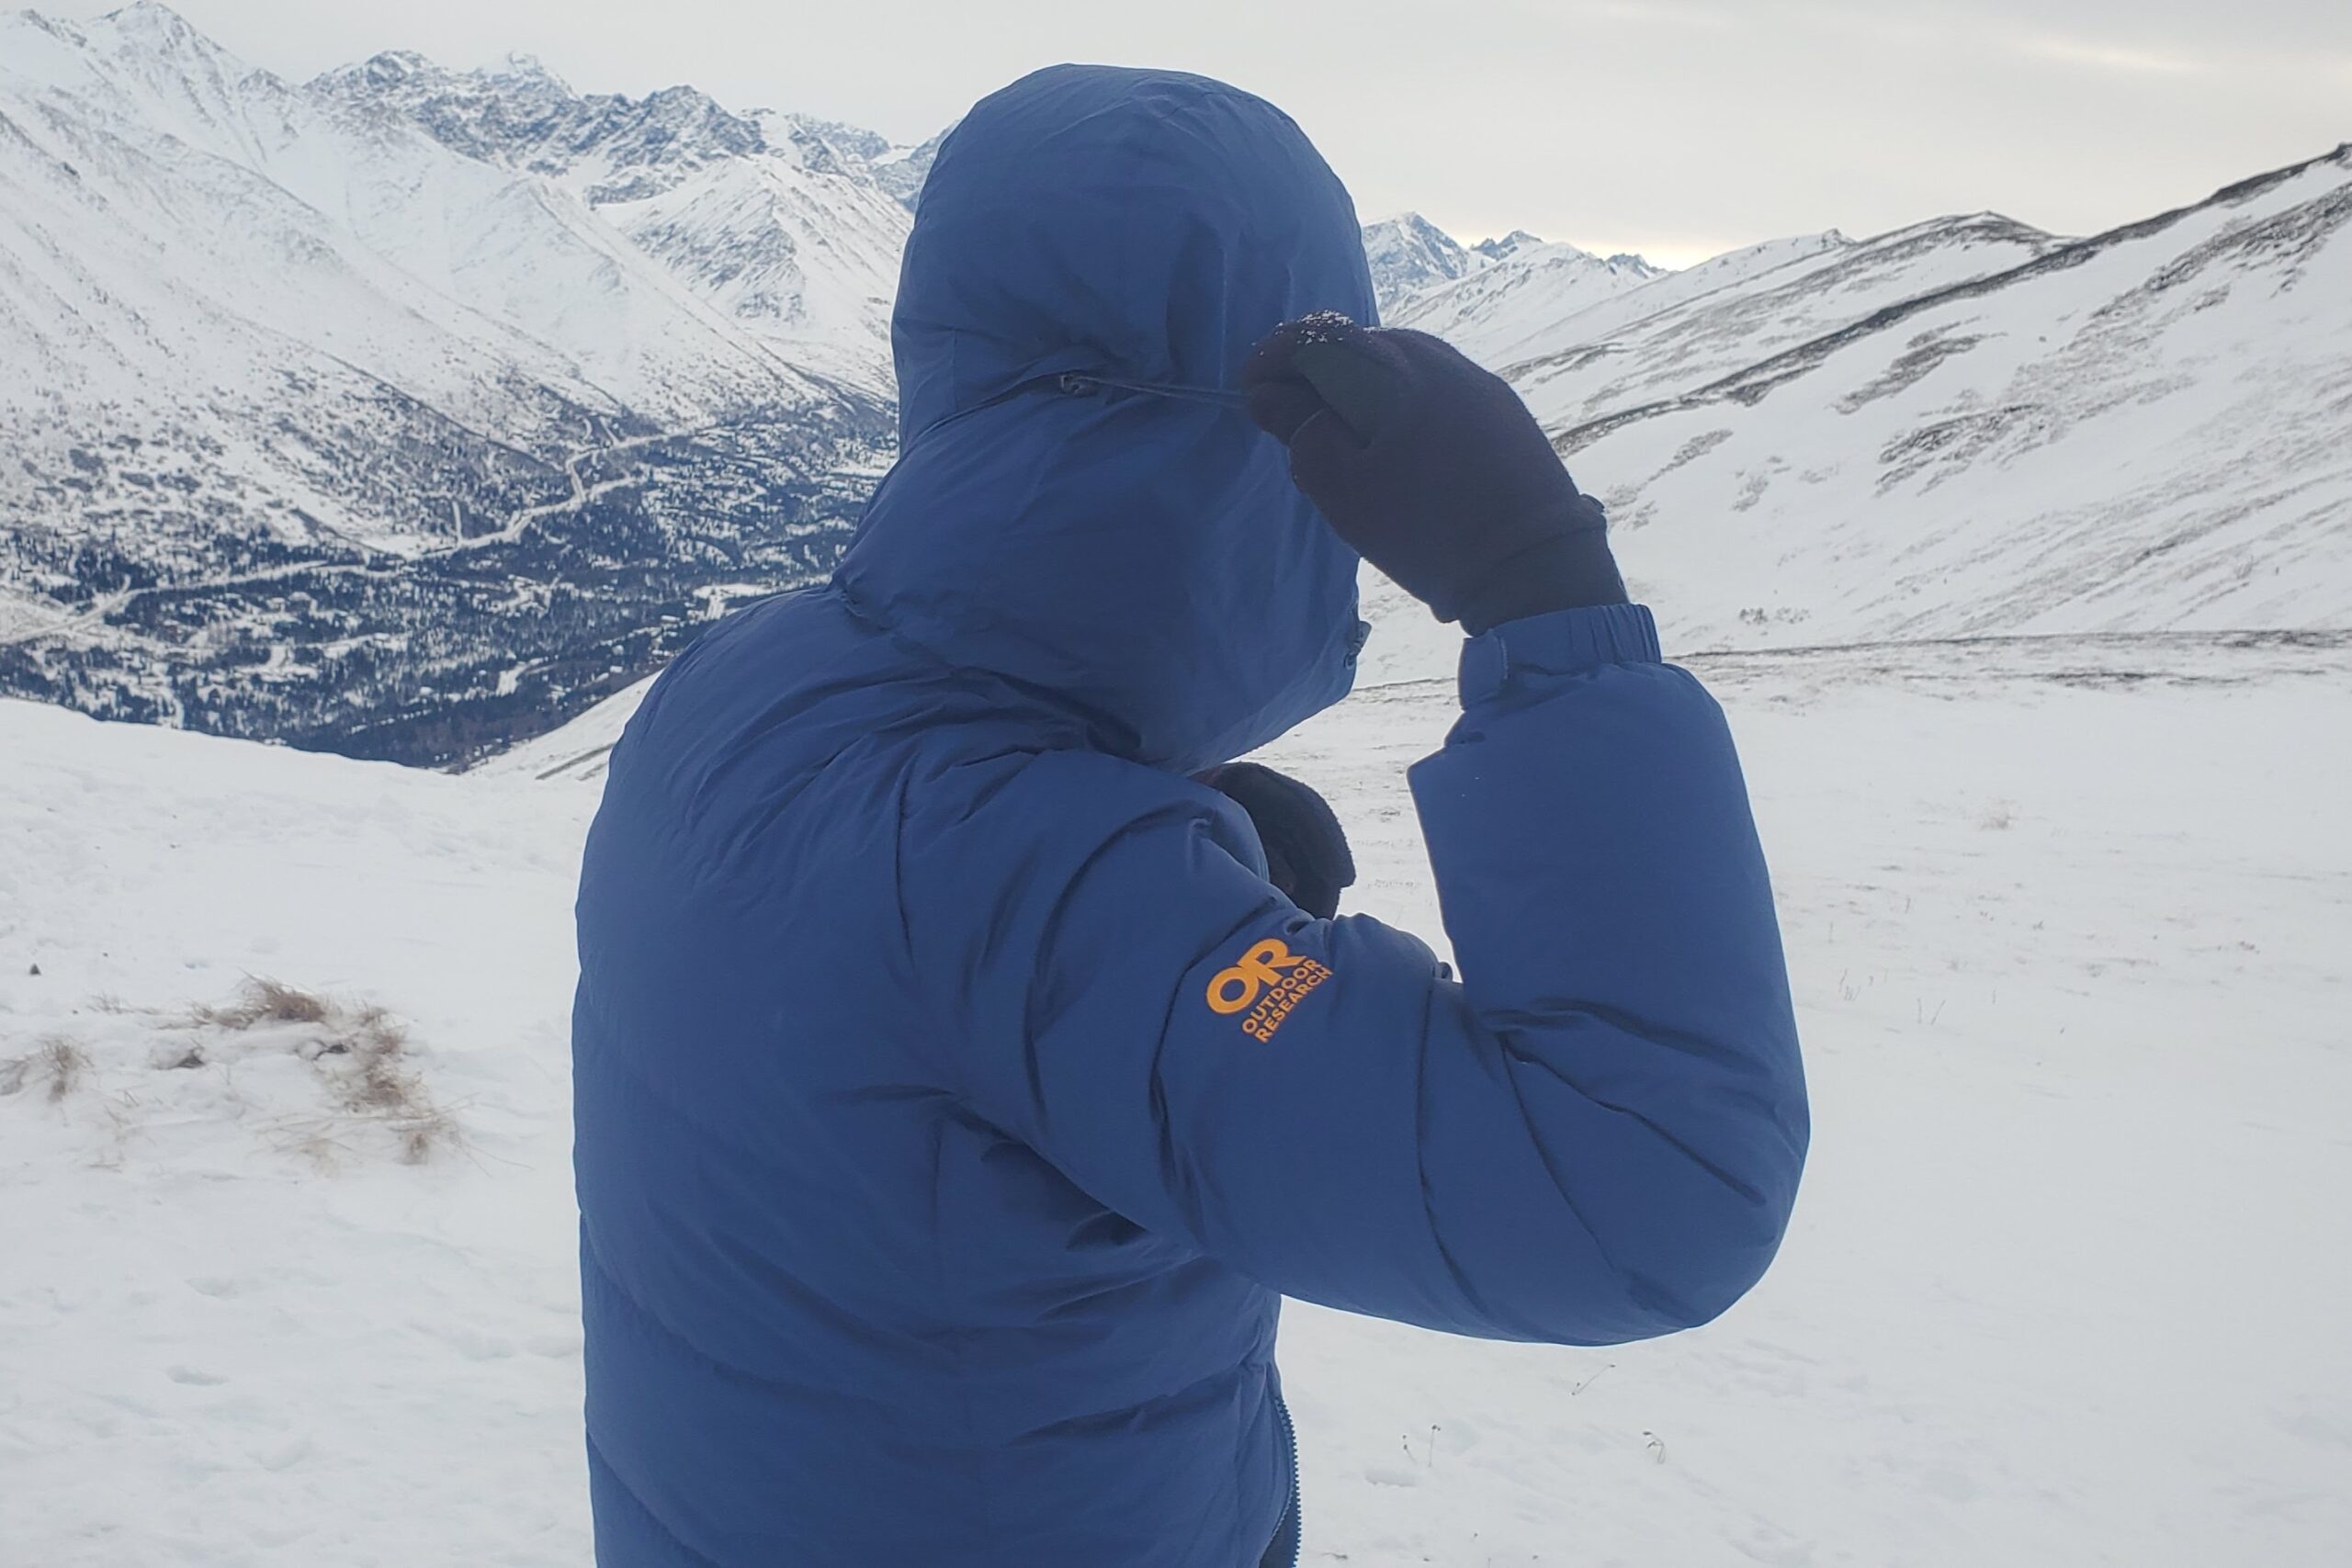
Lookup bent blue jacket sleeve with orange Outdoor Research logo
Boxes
[917,606,1806,1345]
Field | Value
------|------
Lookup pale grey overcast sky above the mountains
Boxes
[106,0,2352,264]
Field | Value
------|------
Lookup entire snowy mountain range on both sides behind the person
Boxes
[0,5,2352,764]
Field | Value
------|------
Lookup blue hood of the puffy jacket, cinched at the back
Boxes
[835,66,1374,771]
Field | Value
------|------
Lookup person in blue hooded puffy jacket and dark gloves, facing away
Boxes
[574,66,1806,1568]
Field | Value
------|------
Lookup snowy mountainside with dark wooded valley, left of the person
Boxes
[0,5,908,761]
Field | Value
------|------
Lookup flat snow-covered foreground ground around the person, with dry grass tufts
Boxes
[0,637,2352,1568]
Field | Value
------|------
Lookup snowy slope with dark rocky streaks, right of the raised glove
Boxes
[1552,146,2352,647]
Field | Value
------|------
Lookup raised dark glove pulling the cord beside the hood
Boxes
[1242,312,1625,635]
